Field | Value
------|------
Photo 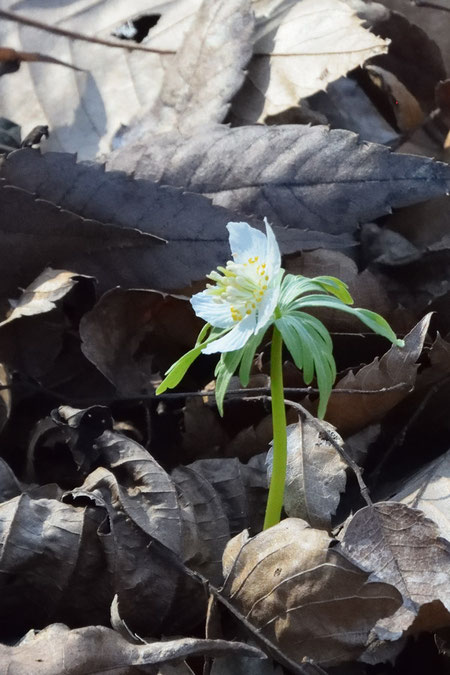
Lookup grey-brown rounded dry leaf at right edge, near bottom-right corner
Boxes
[339,502,450,641]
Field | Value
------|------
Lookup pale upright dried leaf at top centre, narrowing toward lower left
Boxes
[124,0,254,142]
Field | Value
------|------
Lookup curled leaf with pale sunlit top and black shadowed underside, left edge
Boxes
[0,268,95,377]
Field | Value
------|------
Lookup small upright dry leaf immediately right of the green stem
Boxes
[267,418,346,530]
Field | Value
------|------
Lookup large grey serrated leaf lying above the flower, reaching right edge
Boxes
[108,125,450,236]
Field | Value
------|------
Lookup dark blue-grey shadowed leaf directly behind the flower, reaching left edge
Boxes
[0,150,342,292]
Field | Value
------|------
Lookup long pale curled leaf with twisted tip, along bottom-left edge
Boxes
[0,623,264,675]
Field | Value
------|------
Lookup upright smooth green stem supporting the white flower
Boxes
[264,326,287,530]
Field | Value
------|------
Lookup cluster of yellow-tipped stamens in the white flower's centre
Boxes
[207,256,269,322]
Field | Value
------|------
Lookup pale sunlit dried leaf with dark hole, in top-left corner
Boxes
[0,0,196,159]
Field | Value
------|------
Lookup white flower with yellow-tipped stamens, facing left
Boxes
[191,219,281,354]
